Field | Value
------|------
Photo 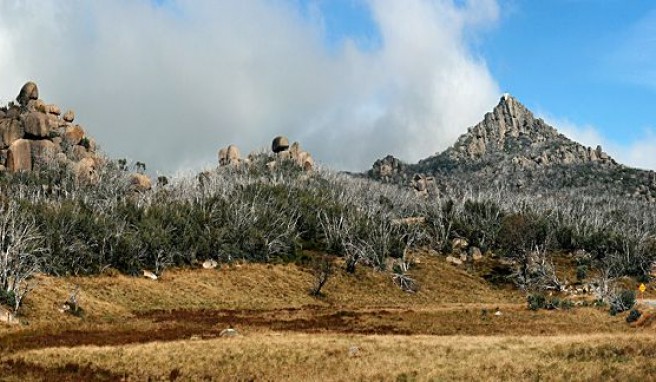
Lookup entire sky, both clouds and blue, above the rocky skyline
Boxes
[0,0,656,175]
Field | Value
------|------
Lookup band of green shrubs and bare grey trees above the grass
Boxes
[0,154,656,310]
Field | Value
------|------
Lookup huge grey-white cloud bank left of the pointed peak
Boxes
[0,0,500,173]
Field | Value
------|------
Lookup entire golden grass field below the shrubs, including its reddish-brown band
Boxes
[0,255,656,381]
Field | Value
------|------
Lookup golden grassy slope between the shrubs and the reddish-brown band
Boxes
[6,256,523,325]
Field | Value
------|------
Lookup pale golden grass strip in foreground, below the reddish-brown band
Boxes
[5,333,656,381]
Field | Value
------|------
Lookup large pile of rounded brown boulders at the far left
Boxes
[0,82,101,177]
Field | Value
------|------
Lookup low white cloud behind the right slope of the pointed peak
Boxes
[541,115,656,170]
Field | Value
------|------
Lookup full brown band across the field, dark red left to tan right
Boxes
[0,305,634,354]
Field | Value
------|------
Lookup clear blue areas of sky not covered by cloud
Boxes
[308,0,656,148]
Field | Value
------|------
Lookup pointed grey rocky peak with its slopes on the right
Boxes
[368,95,656,202]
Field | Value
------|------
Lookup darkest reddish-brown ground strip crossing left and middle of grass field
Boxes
[0,306,412,354]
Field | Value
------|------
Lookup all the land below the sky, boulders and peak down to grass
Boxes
[0,83,656,381]
